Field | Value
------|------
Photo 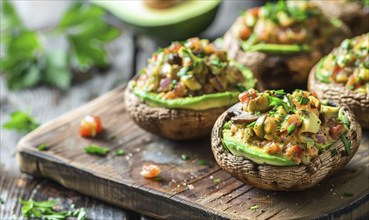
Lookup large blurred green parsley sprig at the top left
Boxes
[0,0,120,90]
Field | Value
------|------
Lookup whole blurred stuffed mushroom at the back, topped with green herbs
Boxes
[223,1,349,89]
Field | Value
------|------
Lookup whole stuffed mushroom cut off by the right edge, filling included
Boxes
[308,33,369,128]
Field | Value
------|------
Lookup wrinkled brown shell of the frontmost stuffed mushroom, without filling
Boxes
[211,103,362,191]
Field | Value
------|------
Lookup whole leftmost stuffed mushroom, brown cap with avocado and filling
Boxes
[125,38,255,140]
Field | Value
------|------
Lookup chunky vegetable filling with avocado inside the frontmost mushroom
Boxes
[222,89,350,166]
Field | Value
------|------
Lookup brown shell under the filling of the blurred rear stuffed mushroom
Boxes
[223,21,349,89]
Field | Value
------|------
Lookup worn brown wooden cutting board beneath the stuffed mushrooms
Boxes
[17,88,369,219]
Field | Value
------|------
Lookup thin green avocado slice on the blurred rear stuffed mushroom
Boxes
[242,43,310,54]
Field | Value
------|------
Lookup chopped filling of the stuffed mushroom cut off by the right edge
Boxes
[315,33,369,93]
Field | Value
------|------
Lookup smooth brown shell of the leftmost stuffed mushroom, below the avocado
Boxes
[124,87,229,140]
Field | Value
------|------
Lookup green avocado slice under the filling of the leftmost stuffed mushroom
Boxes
[133,88,240,110]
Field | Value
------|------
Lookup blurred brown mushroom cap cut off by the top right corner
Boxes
[313,0,369,36]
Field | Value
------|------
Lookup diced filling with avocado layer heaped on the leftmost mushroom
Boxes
[129,38,255,108]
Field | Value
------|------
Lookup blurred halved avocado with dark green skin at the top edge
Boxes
[92,0,221,41]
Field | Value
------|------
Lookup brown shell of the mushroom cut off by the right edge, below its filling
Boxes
[308,67,369,128]
